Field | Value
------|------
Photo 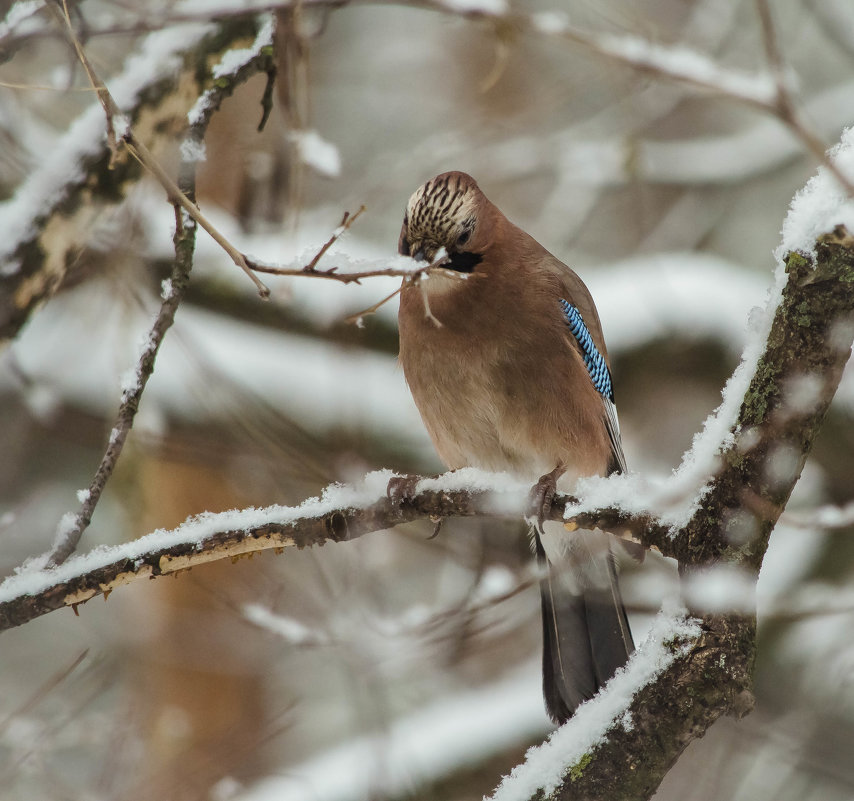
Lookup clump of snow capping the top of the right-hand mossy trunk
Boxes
[775,127,854,264]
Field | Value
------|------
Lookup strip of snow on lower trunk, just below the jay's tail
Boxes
[491,608,701,801]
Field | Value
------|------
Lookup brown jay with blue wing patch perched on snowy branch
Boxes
[389,171,634,724]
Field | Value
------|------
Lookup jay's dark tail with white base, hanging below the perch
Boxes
[534,524,634,723]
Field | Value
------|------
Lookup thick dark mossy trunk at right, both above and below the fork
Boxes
[520,227,854,801]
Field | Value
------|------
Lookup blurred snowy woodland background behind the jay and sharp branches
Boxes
[0,0,854,801]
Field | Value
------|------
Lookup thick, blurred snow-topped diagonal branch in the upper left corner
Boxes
[0,14,270,338]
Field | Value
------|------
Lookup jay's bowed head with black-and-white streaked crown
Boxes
[397,172,489,272]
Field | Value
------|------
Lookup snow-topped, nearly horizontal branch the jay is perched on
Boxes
[0,468,667,630]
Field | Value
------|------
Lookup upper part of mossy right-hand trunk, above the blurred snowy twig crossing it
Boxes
[677,227,854,573]
